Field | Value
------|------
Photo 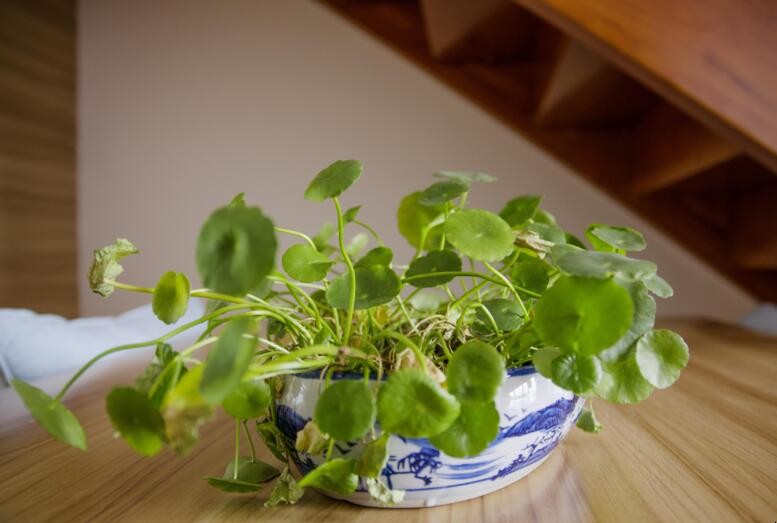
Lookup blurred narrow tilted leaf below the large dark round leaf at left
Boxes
[200,318,255,405]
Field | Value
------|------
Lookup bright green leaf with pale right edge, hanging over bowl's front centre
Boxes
[378,369,460,438]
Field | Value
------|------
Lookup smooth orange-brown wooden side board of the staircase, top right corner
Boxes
[515,0,777,171]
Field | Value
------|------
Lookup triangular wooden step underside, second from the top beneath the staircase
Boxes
[537,40,655,126]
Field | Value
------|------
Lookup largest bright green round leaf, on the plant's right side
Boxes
[534,276,634,355]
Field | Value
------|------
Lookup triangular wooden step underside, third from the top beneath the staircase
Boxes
[632,103,739,194]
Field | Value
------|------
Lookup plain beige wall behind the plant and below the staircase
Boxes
[79,0,753,319]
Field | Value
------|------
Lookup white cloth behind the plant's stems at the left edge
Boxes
[0,300,205,383]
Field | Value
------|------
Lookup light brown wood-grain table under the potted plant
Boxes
[0,321,777,523]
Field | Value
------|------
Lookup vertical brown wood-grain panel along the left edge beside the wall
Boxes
[0,0,77,316]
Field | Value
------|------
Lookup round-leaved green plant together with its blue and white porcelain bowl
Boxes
[13,160,688,506]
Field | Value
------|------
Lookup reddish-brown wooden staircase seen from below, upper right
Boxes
[319,0,777,301]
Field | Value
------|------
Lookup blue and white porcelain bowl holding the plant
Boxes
[277,367,583,508]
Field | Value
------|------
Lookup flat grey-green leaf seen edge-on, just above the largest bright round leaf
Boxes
[552,249,656,281]
